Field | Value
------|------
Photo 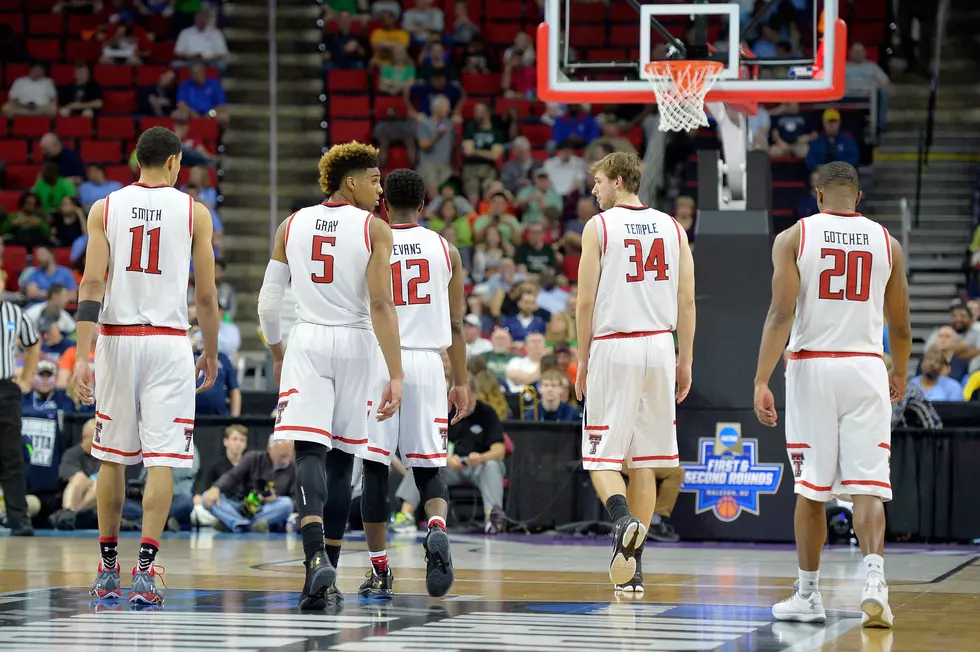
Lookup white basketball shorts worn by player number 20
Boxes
[786,352,892,501]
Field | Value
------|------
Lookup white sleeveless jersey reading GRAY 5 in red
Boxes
[286,202,371,328]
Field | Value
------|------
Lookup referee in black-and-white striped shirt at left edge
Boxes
[0,301,41,536]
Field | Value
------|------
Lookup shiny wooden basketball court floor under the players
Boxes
[0,532,980,652]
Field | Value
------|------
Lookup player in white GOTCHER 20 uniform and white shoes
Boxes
[755,162,912,627]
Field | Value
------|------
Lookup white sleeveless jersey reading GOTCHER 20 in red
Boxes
[789,213,892,355]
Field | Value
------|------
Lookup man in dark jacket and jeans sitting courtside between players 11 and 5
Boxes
[201,435,296,532]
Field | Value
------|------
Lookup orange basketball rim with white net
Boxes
[645,61,725,131]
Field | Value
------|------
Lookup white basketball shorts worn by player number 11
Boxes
[92,326,195,468]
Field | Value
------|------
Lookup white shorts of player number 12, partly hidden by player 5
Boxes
[358,349,449,467]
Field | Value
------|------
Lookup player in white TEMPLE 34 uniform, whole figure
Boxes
[575,153,695,592]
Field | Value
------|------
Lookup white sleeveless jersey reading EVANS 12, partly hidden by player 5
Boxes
[391,224,453,351]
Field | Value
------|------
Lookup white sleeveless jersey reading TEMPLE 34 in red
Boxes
[593,205,683,337]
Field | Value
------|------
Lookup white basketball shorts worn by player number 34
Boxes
[582,331,678,471]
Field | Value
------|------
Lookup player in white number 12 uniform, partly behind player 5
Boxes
[357,169,469,597]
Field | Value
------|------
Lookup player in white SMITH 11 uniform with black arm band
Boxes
[74,127,220,605]
